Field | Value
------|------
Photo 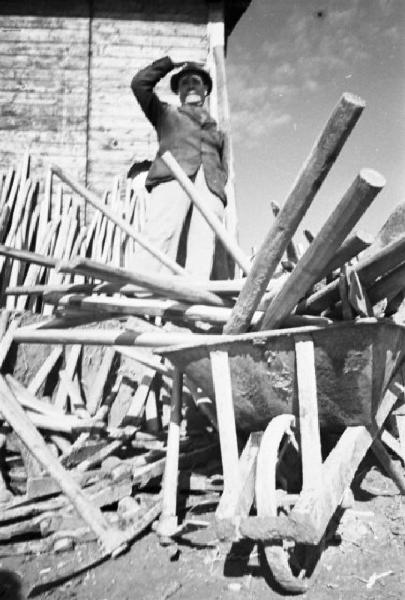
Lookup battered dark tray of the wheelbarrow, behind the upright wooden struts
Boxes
[161,319,405,432]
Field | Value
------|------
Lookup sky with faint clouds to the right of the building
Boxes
[227,0,405,253]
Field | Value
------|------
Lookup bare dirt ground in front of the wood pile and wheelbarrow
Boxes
[0,458,405,600]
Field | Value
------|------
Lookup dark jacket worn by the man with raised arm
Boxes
[131,57,228,204]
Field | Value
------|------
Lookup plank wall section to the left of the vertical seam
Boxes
[0,0,89,180]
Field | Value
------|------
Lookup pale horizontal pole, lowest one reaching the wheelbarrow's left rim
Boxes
[14,327,223,348]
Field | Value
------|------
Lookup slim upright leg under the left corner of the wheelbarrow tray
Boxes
[157,368,183,537]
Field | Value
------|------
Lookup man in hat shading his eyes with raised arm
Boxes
[131,56,228,279]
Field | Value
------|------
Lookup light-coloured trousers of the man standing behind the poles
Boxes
[134,167,224,279]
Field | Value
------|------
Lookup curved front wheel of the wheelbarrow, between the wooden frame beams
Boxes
[255,415,320,593]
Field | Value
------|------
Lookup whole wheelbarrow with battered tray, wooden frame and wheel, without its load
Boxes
[154,319,405,592]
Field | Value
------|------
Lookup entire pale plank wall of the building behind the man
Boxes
[0,0,215,192]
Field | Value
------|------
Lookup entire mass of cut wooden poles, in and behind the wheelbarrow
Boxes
[0,94,405,584]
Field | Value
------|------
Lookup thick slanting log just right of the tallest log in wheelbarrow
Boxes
[261,169,385,329]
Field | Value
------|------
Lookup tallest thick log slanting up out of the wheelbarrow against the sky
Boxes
[224,94,364,334]
